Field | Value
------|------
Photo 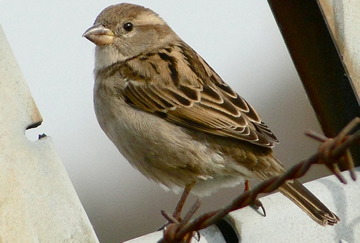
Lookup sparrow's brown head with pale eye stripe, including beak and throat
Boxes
[83,3,178,71]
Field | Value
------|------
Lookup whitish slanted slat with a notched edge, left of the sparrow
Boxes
[0,26,98,243]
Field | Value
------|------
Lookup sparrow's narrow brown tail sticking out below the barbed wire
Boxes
[278,180,340,225]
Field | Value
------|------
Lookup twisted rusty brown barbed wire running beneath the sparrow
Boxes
[159,118,360,243]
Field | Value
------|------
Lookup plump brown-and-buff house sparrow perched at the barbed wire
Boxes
[83,3,339,225]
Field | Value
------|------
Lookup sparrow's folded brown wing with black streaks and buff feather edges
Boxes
[120,43,277,147]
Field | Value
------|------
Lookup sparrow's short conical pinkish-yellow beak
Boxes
[83,25,115,46]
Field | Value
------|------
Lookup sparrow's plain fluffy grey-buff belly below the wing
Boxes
[95,97,255,195]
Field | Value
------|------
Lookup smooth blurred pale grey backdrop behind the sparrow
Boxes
[0,0,325,242]
